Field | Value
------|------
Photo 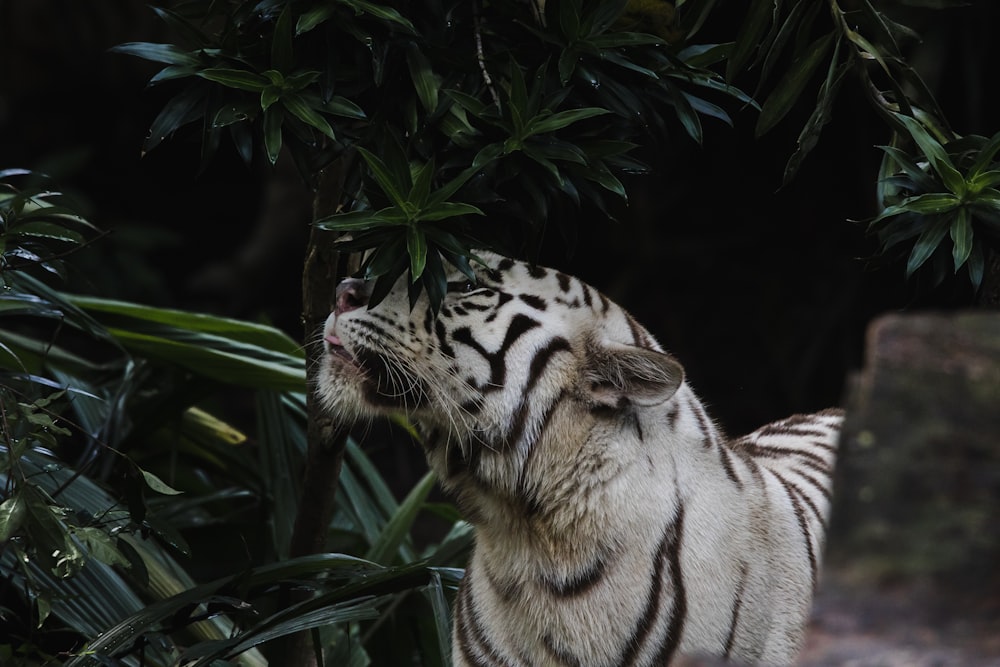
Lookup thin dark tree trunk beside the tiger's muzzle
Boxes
[268,156,357,667]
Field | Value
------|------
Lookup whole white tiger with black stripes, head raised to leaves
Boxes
[316,253,842,667]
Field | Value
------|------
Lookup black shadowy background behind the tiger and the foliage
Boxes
[0,0,1000,432]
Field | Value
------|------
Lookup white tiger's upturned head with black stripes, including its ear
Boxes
[317,252,683,504]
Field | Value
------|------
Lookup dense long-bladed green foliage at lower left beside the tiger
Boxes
[0,175,470,665]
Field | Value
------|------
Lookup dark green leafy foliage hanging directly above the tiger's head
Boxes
[116,0,752,304]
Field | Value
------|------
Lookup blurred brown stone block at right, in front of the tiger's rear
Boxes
[800,312,1000,667]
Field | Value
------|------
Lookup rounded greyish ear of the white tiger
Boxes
[584,343,684,408]
